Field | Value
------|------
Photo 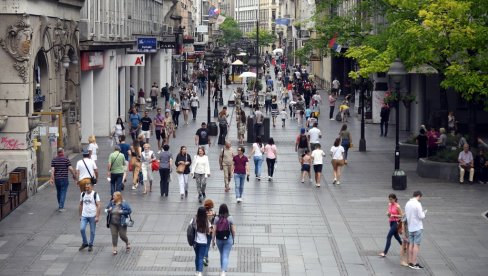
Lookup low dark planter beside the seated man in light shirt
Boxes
[417,158,459,182]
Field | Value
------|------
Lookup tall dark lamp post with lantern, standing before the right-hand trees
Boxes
[388,58,407,190]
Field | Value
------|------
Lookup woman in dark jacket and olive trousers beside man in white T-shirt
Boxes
[106,192,132,255]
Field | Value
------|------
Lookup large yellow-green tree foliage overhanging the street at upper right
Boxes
[308,0,488,109]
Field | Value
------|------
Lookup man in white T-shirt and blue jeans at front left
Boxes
[79,183,101,252]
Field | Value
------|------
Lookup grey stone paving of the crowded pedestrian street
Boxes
[0,80,488,275]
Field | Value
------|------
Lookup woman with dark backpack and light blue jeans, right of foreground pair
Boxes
[212,204,236,276]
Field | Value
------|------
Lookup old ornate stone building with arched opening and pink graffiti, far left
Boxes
[0,0,85,195]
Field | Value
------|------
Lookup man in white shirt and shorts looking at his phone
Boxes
[405,191,427,269]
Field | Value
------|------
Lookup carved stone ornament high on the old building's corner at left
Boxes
[0,14,32,83]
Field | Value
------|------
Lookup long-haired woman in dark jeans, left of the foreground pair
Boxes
[193,206,210,276]
